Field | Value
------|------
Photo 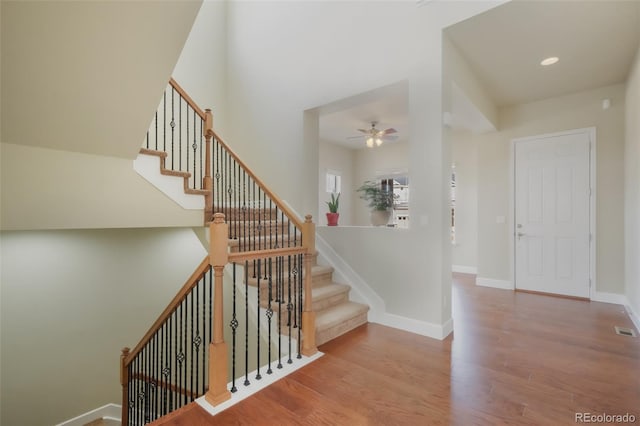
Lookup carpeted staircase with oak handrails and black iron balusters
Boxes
[120,80,369,425]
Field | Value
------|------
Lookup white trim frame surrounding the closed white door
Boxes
[509,127,597,300]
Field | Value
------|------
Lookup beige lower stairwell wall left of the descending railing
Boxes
[0,228,206,426]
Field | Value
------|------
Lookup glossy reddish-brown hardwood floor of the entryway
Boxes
[154,274,640,426]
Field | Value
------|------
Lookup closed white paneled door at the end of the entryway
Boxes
[514,131,591,298]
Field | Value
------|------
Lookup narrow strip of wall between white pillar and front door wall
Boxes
[451,130,478,272]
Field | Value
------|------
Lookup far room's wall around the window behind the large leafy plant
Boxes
[351,142,408,226]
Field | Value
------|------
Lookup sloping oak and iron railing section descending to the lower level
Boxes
[120,256,214,425]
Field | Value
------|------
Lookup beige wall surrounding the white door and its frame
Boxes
[474,85,625,294]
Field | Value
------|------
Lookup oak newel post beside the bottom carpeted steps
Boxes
[302,214,318,356]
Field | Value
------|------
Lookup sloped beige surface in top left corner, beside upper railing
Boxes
[0,0,202,160]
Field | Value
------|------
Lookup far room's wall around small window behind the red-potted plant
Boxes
[316,141,356,226]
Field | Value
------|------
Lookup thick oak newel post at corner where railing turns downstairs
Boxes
[205,213,231,406]
